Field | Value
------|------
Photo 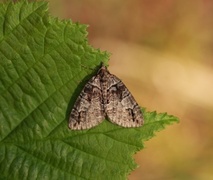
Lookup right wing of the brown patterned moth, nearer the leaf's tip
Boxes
[105,74,144,127]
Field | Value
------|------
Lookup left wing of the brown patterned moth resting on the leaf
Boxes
[69,76,104,130]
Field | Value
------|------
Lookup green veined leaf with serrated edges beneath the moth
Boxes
[0,1,178,180]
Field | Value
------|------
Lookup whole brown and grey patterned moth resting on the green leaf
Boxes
[69,65,144,130]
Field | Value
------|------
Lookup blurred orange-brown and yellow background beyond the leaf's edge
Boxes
[23,0,213,180]
